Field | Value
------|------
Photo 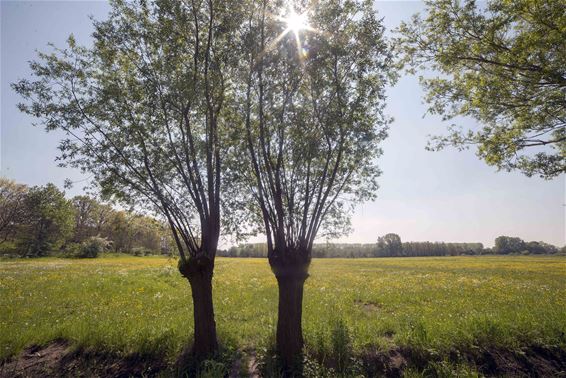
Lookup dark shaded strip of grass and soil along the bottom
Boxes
[0,332,566,378]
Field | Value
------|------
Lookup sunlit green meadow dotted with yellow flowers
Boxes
[0,256,566,376]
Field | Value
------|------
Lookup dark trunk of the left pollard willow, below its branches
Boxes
[180,255,218,360]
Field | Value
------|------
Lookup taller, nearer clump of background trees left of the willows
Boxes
[0,178,171,257]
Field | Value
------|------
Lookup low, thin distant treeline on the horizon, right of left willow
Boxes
[219,234,566,258]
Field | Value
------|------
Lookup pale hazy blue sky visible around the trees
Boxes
[0,0,566,246]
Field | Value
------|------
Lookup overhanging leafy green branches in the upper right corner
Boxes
[397,0,566,179]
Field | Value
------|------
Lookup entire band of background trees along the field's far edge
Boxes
[0,178,566,258]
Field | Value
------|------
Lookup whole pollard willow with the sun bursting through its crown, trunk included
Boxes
[240,0,395,370]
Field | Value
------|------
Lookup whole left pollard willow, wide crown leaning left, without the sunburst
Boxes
[13,0,245,357]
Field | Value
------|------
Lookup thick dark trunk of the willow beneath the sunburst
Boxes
[272,258,308,376]
